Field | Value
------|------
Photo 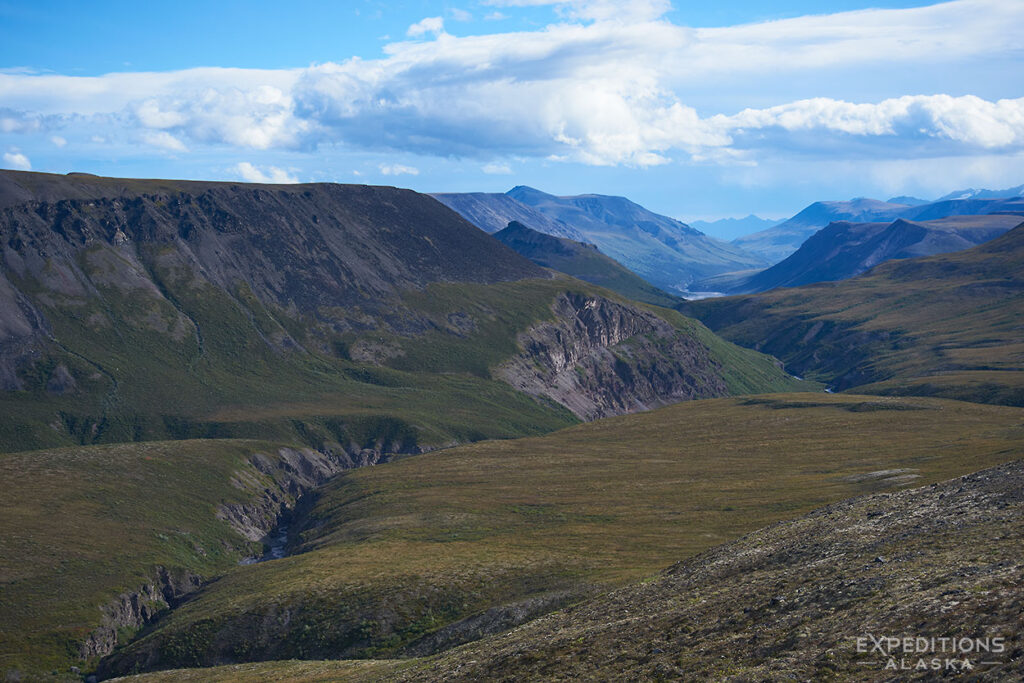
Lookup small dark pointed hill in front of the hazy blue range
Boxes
[494,221,679,307]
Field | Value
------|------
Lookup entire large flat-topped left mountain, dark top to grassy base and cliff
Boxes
[0,171,794,453]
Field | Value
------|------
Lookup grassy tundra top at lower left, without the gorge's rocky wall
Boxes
[0,440,307,674]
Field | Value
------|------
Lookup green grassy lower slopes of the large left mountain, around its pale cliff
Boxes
[0,264,800,451]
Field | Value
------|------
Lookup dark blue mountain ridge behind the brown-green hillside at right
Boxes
[709,214,1024,294]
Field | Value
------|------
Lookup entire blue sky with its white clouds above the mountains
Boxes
[0,0,1024,232]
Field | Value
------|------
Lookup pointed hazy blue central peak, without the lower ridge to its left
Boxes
[508,185,764,292]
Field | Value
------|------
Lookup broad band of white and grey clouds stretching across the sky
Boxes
[0,0,1024,168]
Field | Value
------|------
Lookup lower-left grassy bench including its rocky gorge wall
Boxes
[0,439,380,680]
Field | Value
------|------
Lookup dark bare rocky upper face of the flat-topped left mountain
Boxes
[0,172,545,335]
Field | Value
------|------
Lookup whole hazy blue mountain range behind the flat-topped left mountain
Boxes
[435,185,767,292]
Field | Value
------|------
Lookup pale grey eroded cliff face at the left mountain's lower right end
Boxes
[496,294,728,420]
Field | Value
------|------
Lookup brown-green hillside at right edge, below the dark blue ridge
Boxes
[683,226,1024,405]
